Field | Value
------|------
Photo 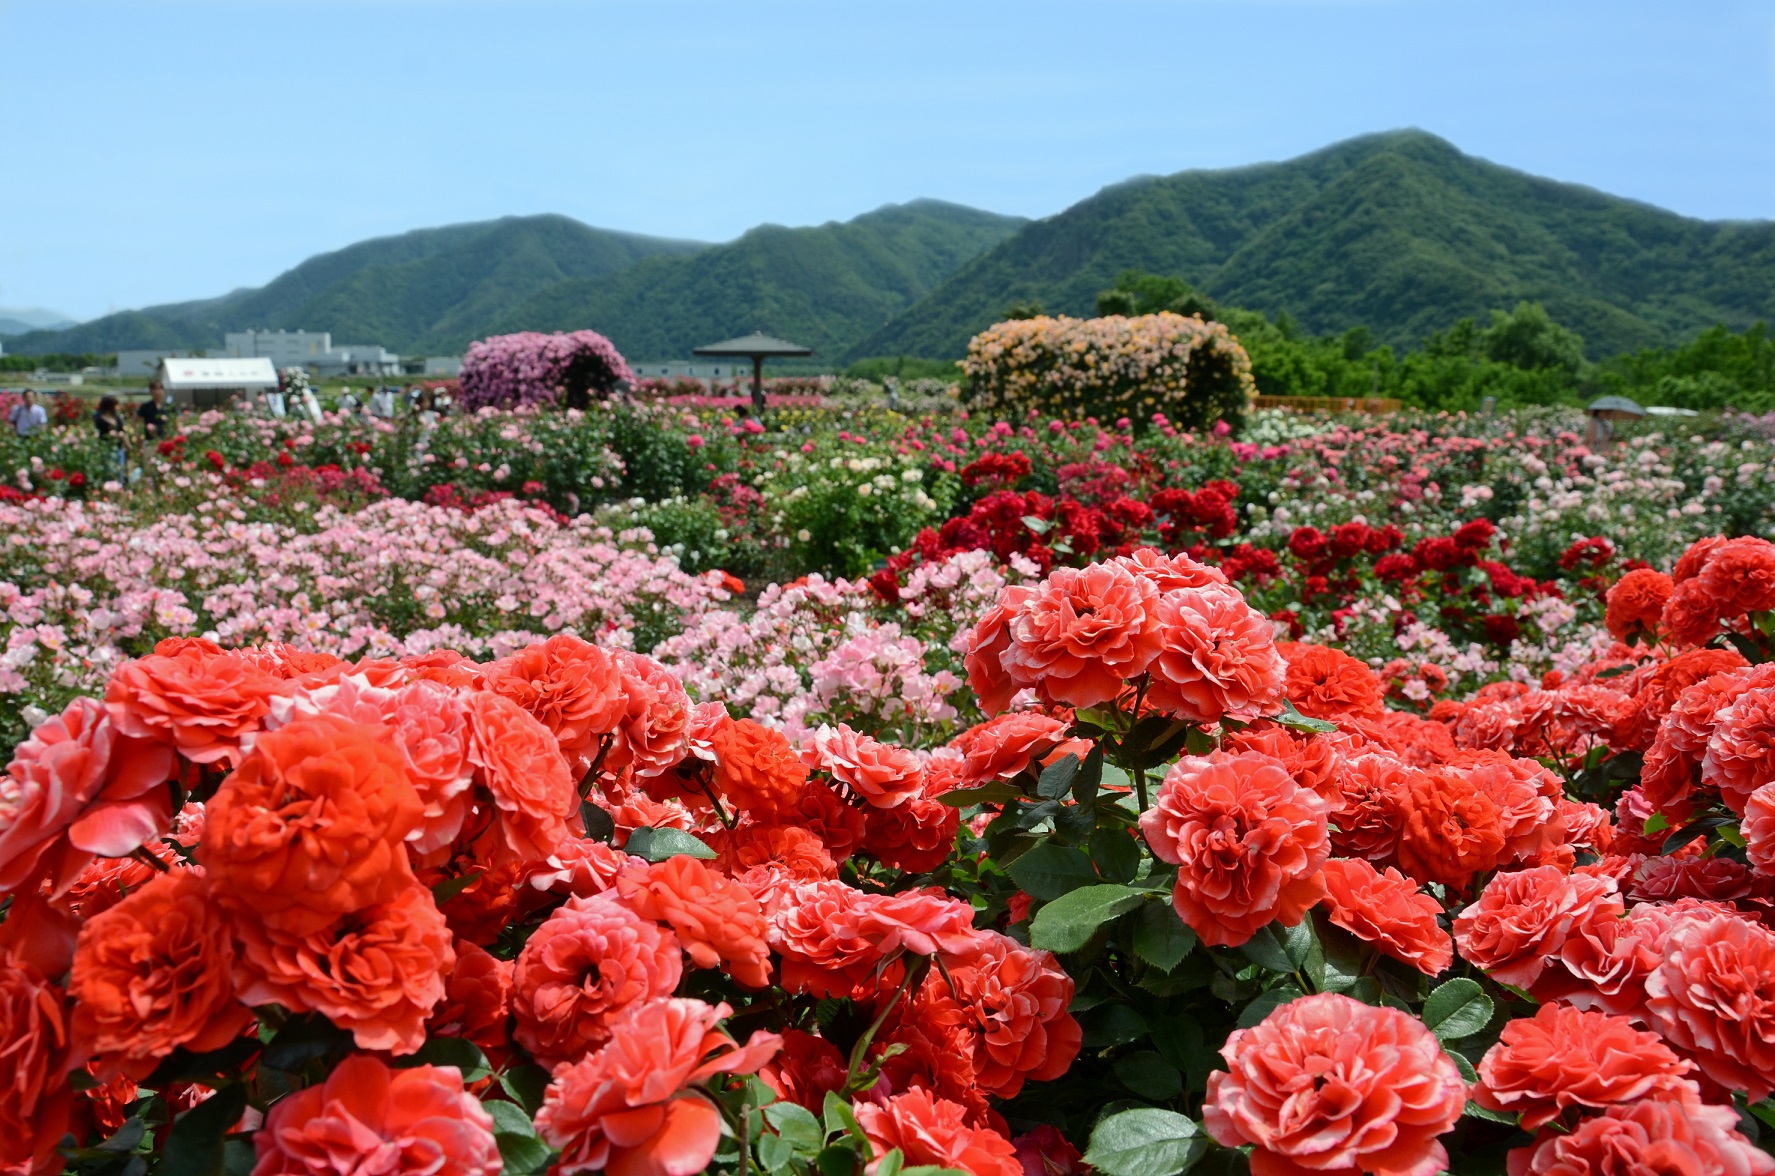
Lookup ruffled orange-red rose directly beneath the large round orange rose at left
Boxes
[234,883,456,1054]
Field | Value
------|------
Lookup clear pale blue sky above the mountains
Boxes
[0,0,1775,318]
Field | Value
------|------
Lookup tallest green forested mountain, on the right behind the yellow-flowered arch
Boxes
[848,131,1775,358]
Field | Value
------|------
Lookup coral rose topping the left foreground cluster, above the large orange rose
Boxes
[105,637,286,763]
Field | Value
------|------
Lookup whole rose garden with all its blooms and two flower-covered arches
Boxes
[0,314,1775,1176]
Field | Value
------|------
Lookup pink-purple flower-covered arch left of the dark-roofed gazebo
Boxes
[462,330,635,408]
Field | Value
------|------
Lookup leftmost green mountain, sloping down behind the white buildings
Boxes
[7,215,708,355]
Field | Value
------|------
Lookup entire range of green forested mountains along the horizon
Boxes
[13,131,1775,364]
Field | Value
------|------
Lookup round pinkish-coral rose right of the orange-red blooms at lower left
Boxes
[511,892,683,1066]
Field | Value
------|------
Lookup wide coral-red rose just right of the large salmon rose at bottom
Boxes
[1473,1004,1700,1132]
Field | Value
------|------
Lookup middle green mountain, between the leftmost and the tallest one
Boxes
[499,200,1028,362]
